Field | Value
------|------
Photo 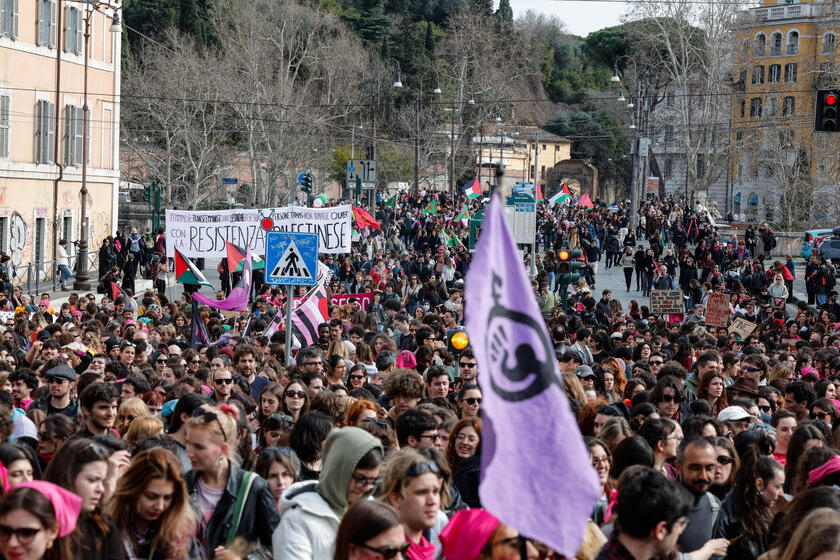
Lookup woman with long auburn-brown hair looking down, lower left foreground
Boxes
[109,447,200,560]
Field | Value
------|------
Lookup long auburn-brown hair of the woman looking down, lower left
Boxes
[109,447,198,558]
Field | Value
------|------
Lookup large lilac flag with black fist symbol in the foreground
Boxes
[465,196,601,558]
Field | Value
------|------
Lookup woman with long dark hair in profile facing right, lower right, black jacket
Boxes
[712,446,785,560]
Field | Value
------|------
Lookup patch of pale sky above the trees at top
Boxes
[508,0,624,37]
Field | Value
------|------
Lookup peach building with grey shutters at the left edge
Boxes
[0,0,120,270]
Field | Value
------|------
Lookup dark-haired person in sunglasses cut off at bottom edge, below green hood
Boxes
[332,500,411,560]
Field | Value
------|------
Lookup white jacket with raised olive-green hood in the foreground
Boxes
[271,426,384,560]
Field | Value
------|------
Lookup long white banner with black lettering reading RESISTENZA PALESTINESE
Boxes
[166,204,353,258]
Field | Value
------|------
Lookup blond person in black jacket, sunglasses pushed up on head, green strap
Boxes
[184,404,279,558]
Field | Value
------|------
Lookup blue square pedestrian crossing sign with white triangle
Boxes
[265,231,318,286]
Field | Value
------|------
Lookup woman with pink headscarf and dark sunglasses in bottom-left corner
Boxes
[0,481,81,559]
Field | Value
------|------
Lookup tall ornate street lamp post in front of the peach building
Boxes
[74,0,122,291]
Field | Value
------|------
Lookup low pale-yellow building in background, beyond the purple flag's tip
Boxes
[473,124,572,184]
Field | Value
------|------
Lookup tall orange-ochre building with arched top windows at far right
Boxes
[730,0,840,225]
